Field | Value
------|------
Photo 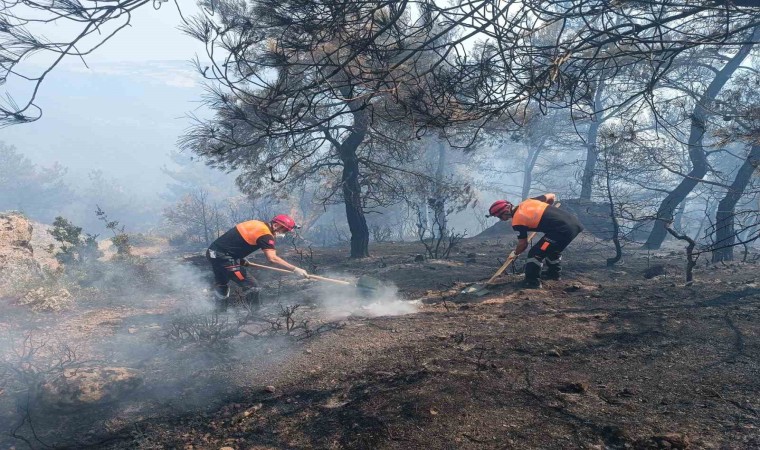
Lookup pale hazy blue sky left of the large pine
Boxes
[0,2,217,196]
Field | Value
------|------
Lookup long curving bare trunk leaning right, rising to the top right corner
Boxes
[644,31,760,249]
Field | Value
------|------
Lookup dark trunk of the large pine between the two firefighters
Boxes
[338,110,369,258]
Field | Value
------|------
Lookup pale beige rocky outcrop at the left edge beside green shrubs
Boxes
[0,212,42,298]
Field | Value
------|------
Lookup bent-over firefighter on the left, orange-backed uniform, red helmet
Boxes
[206,214,309,309]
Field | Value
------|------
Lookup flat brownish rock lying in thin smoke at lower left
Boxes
[37,367,143,410]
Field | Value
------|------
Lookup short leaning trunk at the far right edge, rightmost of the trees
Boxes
[712,145,760,262]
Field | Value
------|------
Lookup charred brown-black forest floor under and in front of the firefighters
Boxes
[1,238,760,449]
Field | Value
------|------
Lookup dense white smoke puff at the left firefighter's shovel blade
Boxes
[314,274,419,320]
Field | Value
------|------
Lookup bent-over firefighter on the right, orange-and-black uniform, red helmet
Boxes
[488,194,583,289]
